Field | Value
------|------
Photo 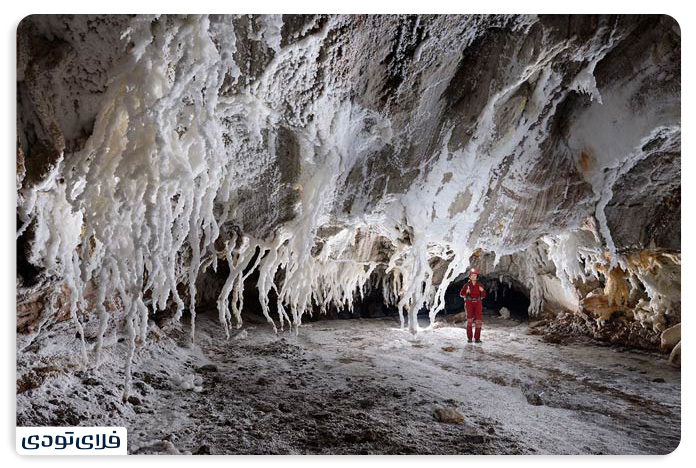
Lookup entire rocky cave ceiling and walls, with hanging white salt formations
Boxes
[17,15,681,391]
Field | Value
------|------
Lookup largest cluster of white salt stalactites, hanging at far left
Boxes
[19,17,245,393]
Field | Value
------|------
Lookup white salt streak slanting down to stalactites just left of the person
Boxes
[386,19,608,331]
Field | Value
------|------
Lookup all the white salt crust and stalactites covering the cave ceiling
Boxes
[19,16,678,384]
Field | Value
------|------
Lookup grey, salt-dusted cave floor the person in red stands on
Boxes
[17,314,681,454]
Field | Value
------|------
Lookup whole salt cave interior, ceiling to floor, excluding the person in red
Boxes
[16,15,681,454]
